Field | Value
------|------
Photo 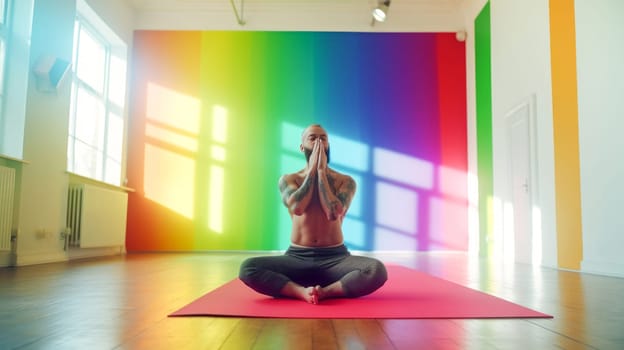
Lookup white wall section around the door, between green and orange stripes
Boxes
[490,0,557,266]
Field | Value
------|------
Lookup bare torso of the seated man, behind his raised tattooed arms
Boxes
[287,171,347,247]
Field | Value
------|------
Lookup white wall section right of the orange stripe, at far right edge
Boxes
[575,0,624,276]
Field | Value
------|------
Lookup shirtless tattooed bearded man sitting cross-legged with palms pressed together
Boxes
[239,124,387,304]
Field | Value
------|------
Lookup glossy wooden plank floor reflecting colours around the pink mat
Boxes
[0,253,624,350]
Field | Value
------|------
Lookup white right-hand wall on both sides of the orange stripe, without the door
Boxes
[482,0,624,276]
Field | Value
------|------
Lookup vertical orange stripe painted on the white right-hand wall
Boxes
[550,0,583,270]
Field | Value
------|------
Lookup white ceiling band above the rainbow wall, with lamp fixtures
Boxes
[124,0,467,32]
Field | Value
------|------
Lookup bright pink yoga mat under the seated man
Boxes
[169,265,552,319]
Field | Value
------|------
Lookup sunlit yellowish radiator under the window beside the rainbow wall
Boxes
[66,184,128,248]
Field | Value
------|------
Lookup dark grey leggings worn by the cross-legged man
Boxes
[239,245,388,298]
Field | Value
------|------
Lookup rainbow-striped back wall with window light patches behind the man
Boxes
[127,31,468,251]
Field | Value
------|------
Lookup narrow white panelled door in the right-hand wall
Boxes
[507,103,533,263]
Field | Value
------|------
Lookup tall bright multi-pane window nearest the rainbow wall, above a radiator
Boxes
[67,1,127,185]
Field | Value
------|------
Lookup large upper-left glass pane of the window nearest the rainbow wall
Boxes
[76,26,106,94]
